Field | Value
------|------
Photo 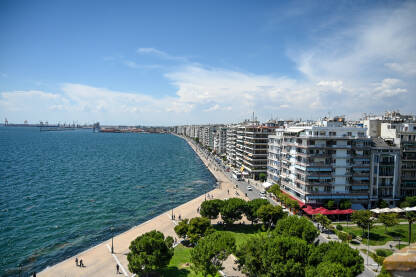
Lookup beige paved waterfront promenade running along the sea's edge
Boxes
[38,135,244,277]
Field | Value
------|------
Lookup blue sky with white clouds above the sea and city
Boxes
[0,0,416,126]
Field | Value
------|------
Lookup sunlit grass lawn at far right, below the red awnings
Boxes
[343,224,416,245]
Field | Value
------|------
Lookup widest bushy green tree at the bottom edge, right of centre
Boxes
[236,234,310,277]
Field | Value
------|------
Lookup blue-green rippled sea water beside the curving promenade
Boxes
[0,127,215,276]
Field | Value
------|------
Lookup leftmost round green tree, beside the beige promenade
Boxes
[127,230,173,276]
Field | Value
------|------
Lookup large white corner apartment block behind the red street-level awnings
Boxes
[267,118,371,206]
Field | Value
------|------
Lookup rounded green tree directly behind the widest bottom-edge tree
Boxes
[273,216,318,243]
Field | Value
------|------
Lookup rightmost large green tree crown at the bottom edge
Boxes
[308,241,364,277]
